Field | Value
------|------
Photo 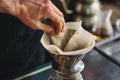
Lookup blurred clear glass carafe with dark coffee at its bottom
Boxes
[92,10,113,40]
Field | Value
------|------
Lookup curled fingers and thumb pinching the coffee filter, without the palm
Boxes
[27,0,65,34]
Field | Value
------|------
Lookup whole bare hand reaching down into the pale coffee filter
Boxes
[3,0,65,34]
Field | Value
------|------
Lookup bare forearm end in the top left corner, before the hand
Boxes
[0,0,15,14]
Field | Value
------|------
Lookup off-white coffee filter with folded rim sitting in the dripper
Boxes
[41,22,95,55]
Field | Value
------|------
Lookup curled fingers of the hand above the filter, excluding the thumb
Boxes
[39,2,65,34]
